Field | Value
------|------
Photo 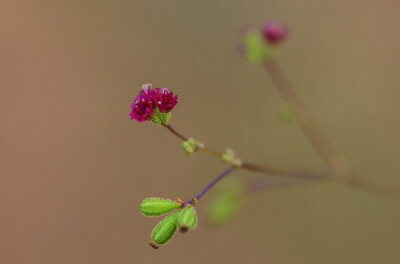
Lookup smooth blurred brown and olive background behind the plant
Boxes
[0,0,400,264]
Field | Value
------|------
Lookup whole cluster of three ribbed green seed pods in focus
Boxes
[140,198,197,249]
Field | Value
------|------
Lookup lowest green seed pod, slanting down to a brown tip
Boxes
[150,212,178,246]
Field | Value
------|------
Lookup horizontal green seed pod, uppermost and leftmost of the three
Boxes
[140,198,181,216]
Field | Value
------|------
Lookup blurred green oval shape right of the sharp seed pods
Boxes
[207,178,245,225]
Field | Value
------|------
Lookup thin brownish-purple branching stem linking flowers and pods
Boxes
[164,60,400,196]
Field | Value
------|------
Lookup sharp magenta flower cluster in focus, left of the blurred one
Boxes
[130,84,178,122]
